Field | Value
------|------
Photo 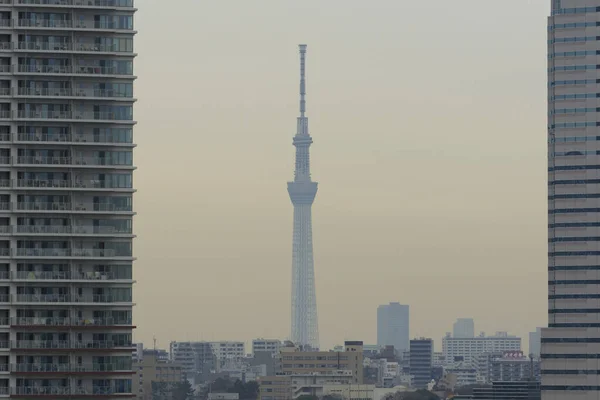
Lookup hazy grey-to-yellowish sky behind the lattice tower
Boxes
[134,0,550,350]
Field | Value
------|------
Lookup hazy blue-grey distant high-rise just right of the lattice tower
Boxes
[377,303,410,354]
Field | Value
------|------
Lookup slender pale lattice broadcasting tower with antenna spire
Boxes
[288,44,319,348]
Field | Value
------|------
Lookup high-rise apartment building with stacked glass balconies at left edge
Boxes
[0,0,135,399]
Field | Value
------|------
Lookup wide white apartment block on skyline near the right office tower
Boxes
[442,332,521,365]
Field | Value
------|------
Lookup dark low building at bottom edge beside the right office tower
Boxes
[452,381,540,400]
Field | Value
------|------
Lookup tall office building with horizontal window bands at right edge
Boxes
[541,0,600,400]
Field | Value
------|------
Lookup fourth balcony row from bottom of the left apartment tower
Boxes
[10,317,133,329]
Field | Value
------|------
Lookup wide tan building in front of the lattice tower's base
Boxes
[279,341,363,384]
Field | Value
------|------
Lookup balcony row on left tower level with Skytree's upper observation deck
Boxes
[15,133,135,147]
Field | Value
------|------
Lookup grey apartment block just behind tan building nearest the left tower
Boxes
[169,342,217,383]
